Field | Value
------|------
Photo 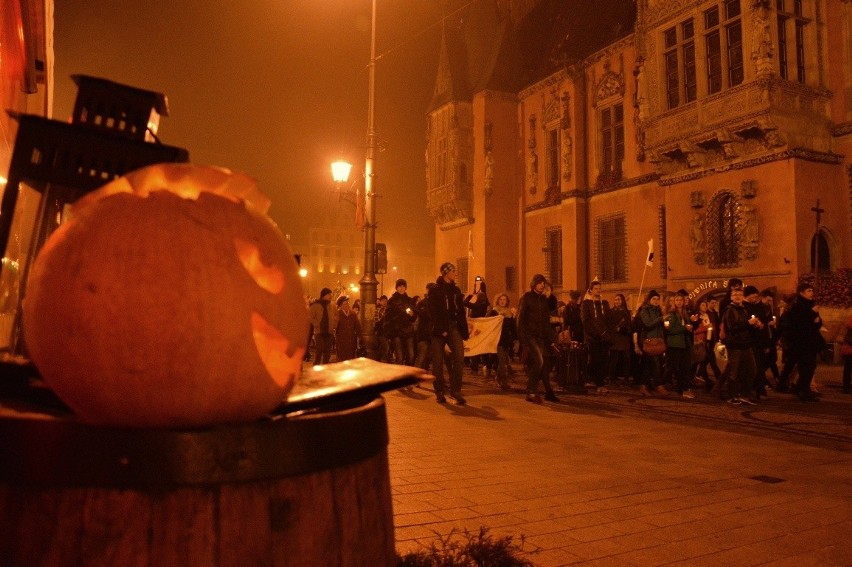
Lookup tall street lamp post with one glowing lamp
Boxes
[332,0,379,359]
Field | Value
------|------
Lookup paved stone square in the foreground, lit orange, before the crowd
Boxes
[385,366,852,567]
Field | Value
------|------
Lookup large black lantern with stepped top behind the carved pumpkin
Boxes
[0,75,189,355]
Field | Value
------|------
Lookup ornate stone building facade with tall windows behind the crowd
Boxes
[426,0,852,303]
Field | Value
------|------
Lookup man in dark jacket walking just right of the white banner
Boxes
[518,274,559,404]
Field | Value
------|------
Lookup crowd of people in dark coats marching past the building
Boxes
[302,268,852,405]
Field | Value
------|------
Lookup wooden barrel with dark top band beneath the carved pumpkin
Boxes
[0,398,395,567]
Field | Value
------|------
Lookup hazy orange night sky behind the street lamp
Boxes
[54,0,465,254]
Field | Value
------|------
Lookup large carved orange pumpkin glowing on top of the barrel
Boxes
[23,165,308,427]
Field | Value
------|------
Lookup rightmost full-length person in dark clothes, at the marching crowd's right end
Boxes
[779,284,825,402]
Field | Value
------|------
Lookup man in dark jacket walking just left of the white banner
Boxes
[427,262,468,406]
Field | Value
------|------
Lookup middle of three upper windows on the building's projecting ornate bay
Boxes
[704,0,744,94]
